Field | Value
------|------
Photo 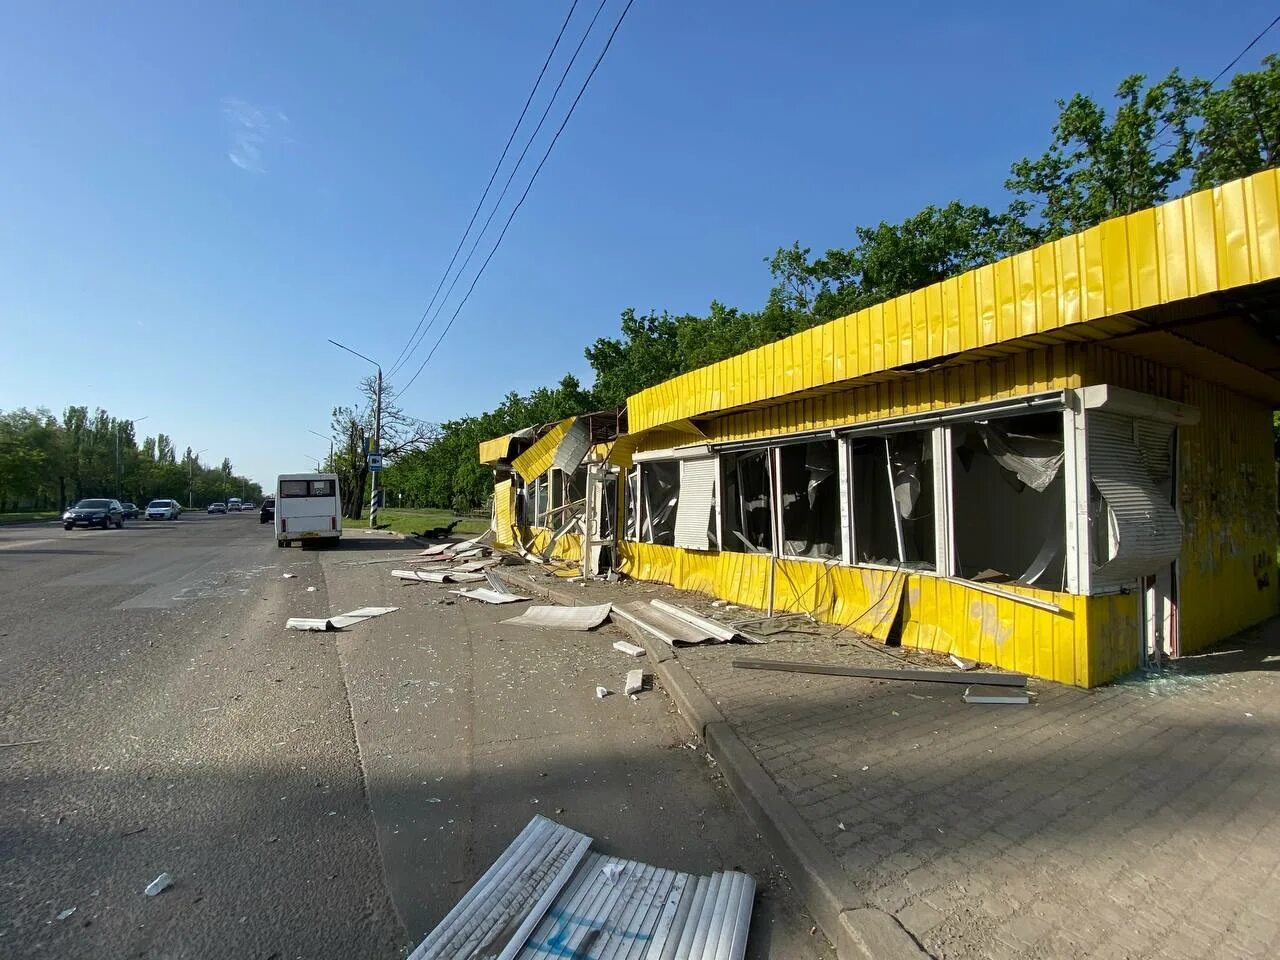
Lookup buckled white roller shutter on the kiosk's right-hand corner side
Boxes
[1085,410,1183,590]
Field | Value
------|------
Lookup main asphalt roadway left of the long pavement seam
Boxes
[0,513,406,957]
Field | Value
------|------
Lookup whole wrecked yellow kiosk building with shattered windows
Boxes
[481,173,1280,686]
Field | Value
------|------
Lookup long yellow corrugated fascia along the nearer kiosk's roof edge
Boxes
[627,170,1280,433]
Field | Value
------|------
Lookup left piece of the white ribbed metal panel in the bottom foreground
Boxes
[408,817,591,960]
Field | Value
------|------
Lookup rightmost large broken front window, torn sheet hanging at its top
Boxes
[951,412,1066,590]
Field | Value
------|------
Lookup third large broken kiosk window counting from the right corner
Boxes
[778,440,842,559]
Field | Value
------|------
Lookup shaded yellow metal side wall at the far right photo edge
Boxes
[1178,378,1277,653]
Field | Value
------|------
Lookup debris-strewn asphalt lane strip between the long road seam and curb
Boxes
[316,532,832,960]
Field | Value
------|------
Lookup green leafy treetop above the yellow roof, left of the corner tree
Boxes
[1005,69,1208,241]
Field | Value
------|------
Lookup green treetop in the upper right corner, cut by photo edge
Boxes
[1192,54,1280,189]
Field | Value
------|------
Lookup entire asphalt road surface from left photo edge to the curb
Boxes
[0,513,829,959]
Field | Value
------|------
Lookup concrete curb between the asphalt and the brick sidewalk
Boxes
[498,567,929,960]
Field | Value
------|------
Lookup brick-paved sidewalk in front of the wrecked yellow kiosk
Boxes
[504,568,1280,960]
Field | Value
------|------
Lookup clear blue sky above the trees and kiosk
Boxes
[0,0,1280,480]
